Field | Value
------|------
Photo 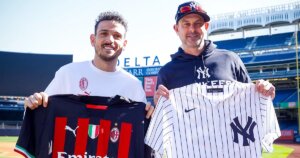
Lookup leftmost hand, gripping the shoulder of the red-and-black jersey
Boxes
[24,92,48,110]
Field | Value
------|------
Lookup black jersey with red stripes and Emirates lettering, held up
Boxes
[15,95,146,158]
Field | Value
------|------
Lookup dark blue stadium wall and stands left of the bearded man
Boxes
[0,51,73,136]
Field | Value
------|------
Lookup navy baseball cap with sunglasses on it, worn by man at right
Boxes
[175,1,210,23]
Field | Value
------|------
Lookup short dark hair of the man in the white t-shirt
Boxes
[95,11,127,34]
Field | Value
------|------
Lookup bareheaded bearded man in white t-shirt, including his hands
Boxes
[25,12,154,118]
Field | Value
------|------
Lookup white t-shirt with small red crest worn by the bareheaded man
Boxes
[45,61,147,103]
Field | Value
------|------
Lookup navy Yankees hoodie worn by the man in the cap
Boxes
[157,40,251,89]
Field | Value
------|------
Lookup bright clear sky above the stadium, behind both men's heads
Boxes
[0,0,295,64]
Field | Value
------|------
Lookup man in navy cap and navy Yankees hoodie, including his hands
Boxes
[154,1,275,104]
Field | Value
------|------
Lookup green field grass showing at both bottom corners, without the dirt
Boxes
[0,137,294,158]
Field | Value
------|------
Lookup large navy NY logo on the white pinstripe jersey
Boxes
[230,116,256,146]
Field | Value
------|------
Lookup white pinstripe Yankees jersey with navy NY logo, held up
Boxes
[145,82,280,158]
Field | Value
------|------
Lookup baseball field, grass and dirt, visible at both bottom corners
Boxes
[0,137,300,158]
